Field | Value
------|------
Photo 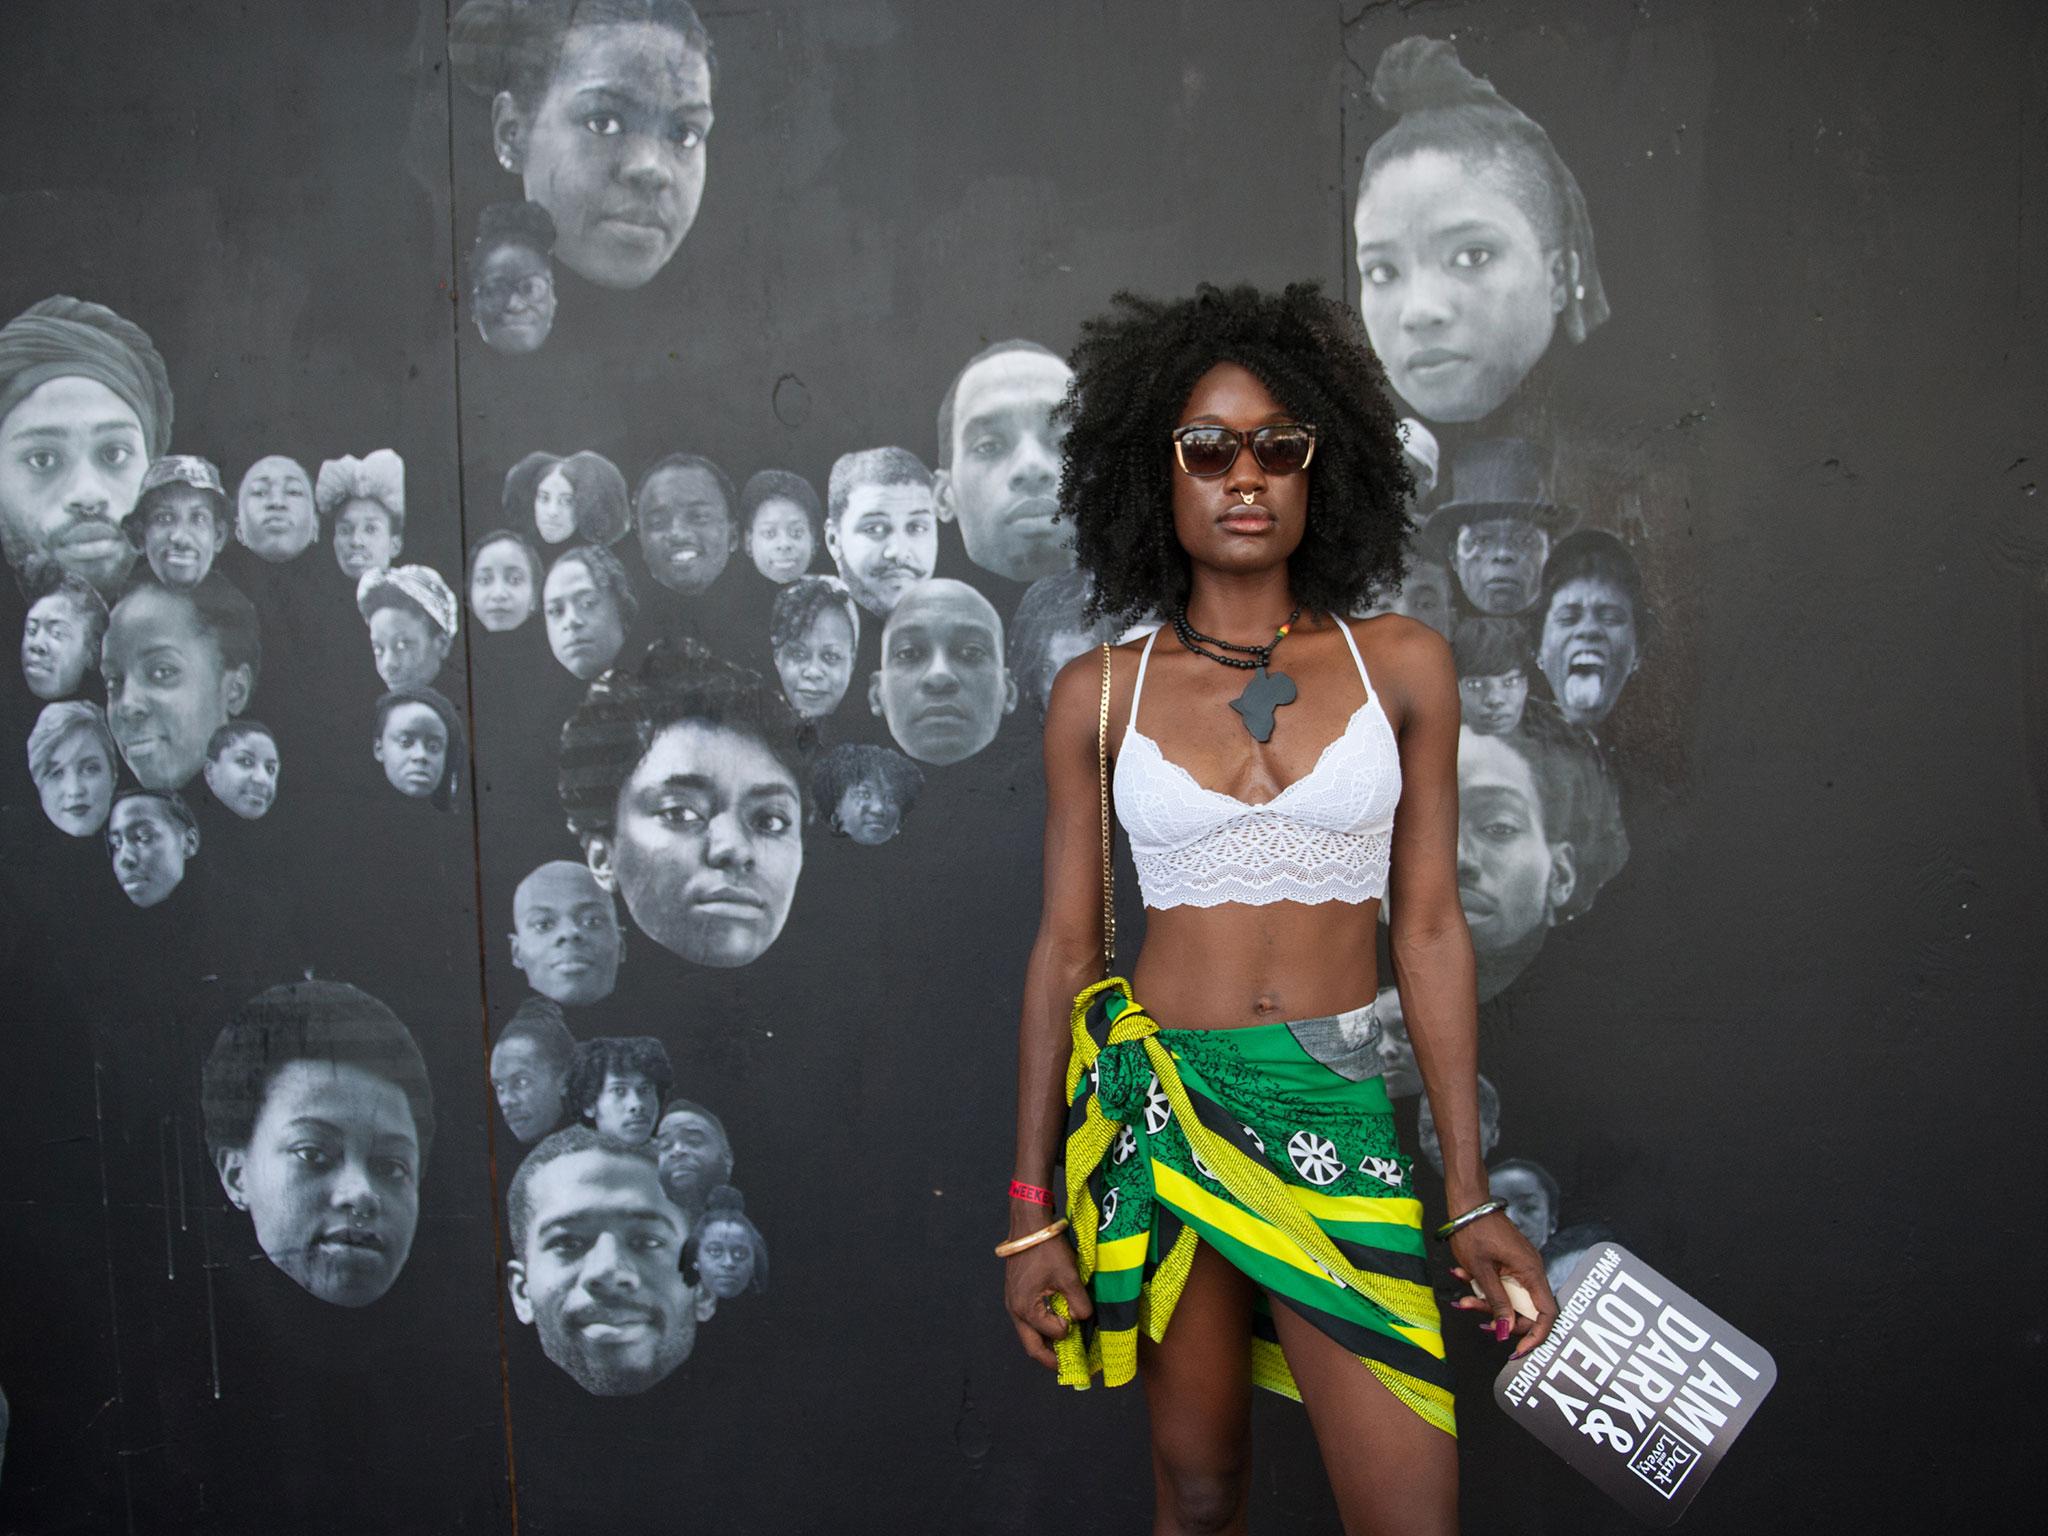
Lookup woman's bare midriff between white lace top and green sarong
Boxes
[1128,901,1380,1030]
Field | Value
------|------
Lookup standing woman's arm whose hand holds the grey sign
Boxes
[1376,618,1556,1356]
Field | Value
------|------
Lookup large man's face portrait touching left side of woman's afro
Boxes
[934,340,1073,582]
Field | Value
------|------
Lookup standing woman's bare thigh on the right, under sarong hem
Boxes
[1274,1298,1458,1536]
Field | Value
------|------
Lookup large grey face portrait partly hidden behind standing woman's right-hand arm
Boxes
[1458,702,1628,1001]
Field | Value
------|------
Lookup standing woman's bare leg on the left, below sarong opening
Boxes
[1139,1243,1255,1536]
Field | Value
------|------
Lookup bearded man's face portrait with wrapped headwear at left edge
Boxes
[0,297,172,602]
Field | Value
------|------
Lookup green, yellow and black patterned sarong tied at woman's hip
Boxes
[1057,977,1458,1434]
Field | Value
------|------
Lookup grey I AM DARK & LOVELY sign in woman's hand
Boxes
[1493,1243,1778,1526]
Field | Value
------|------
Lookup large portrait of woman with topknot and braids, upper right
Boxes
[1354,37,1608,422]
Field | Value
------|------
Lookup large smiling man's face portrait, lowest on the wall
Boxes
[506,1126,717,1397]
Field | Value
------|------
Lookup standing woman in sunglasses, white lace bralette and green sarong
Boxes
[1004,285,1554,1532]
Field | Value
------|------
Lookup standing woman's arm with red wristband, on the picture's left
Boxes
[1004,649,1114,1366]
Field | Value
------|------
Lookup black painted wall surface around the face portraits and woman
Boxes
[0,0,2048,1532]
